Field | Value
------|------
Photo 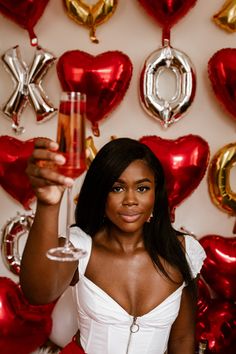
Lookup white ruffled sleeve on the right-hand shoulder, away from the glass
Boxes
[185,235,206,278]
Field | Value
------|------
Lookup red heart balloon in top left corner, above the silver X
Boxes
[0,0,49,45]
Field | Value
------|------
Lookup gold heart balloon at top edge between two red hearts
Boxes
[63,0,118,43]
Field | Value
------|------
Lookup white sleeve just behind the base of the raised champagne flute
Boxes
[70,226,92,274]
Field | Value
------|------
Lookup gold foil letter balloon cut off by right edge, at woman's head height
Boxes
[208,143,236,215]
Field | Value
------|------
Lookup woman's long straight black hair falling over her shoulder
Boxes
[75,138,194,283]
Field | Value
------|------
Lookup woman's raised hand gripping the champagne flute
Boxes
[26,138,74,205]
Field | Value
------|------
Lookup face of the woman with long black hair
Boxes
[105,160,155,233]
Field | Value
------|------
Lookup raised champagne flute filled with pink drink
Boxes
[47,92,87,262]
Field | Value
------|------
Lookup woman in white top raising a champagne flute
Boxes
[20,138,205,354]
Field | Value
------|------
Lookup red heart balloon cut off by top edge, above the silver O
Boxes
[138,0,197,28]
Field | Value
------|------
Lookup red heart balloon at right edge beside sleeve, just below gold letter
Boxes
[200,235,236,301]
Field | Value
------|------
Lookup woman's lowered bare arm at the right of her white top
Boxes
[168,280,197,354]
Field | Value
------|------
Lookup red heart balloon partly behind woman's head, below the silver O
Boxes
[140,134,209,221]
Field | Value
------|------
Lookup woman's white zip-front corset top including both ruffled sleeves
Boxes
[71,227,206,354]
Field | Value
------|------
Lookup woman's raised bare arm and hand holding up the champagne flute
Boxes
[20,138,78,304]
